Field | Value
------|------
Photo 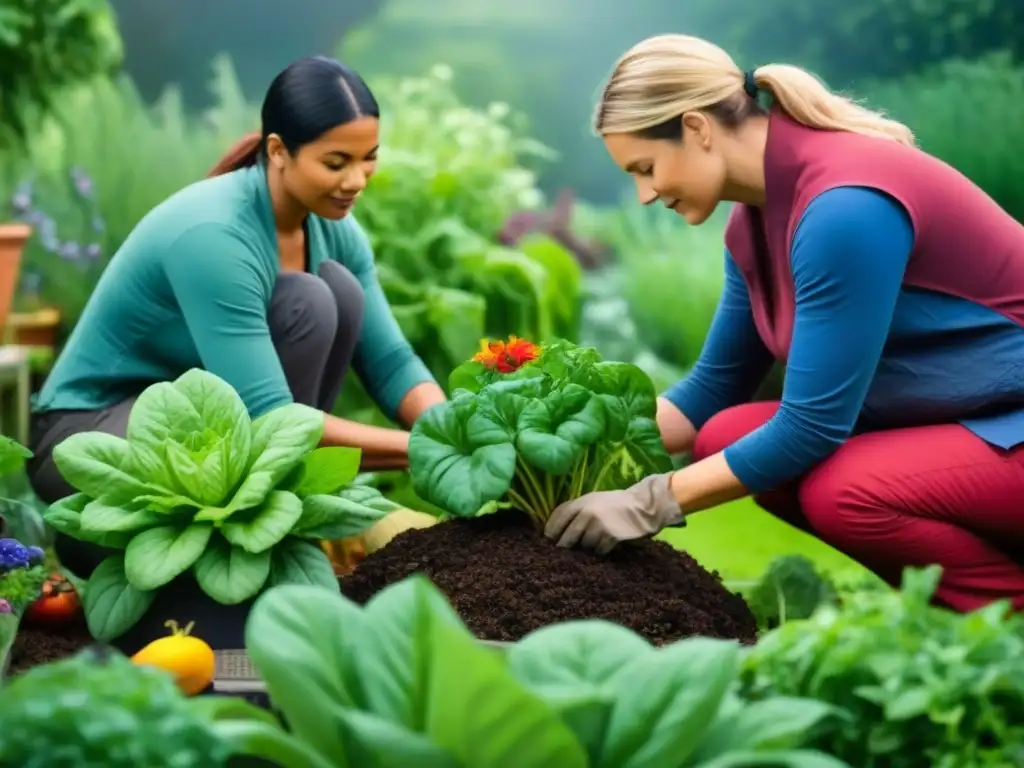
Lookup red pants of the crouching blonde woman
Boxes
[693,402,1024,611]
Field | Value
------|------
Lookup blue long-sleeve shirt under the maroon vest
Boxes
[666,187,1024,493]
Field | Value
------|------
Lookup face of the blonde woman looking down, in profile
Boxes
[604,113,726,225]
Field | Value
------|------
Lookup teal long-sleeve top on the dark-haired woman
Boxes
[34,166,433,418]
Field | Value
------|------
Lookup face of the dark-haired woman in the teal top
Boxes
[267,117,380,219]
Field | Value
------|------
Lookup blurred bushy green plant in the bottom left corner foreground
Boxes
[0,648,324,768]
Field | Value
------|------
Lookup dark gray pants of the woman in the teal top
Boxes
[28,261,364,589]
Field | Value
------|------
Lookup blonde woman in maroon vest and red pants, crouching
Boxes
[547,35,1024,611]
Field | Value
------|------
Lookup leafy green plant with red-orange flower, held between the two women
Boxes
[409,338,672,526]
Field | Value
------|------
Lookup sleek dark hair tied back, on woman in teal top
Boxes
[207,56,380,176]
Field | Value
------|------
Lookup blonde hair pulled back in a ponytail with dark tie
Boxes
[594,35,914,146]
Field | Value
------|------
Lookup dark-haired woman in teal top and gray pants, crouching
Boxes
[29,57,444,651]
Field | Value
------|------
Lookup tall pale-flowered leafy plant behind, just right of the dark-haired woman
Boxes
[348,67,581,387]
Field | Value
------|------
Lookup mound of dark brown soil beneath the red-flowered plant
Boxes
[341,512,757,644]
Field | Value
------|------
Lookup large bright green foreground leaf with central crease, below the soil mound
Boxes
[358,577,588,768]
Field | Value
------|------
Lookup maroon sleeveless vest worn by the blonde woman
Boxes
[725,111,1024,360]
